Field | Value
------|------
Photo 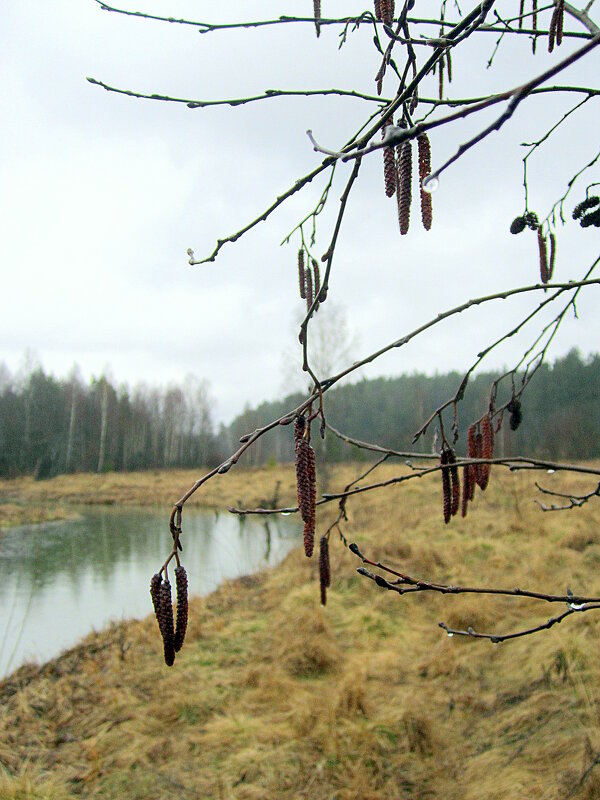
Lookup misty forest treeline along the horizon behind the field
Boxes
[0,350,600,478]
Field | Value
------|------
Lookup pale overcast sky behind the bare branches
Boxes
[0,0,600,421]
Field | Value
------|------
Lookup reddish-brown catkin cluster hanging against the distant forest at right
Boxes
[440,412,496,524]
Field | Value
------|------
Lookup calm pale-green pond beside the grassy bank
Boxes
[0,508,300,677]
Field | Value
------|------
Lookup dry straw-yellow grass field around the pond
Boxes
[0,465,600,800]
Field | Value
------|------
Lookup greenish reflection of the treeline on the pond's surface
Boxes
[0,509,296,599]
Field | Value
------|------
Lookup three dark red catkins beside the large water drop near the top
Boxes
[382,118,433,236]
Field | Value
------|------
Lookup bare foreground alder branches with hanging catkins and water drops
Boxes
[89,0,600,663]
